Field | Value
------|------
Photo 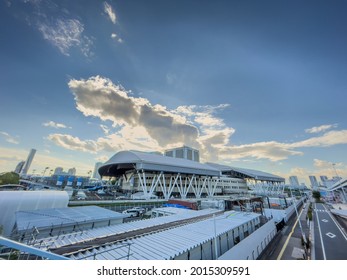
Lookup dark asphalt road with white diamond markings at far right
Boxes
[312,203,347,260]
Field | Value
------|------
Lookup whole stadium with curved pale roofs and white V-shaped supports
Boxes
[99,151,285,199]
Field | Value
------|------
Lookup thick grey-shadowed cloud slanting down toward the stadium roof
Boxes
[69,76,199,147]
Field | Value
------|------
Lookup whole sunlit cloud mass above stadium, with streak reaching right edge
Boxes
[44,76,347,165]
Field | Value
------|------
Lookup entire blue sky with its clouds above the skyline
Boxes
[0,0,347,186]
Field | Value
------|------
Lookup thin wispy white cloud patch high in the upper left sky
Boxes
[38,19,93,57]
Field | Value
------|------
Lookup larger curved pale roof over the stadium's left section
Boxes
[99,151,220,177]
